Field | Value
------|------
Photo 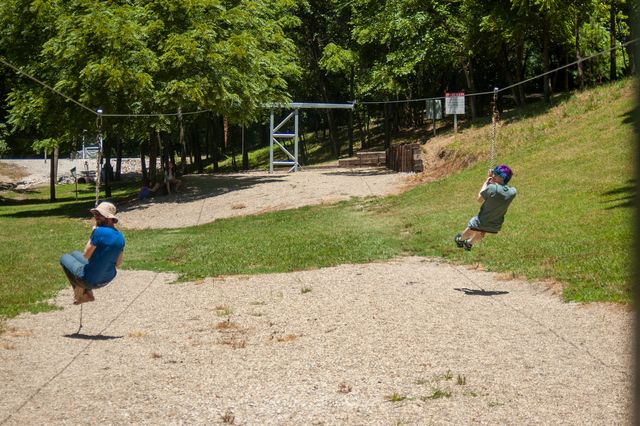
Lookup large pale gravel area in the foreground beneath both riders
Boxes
[0,257,632,425]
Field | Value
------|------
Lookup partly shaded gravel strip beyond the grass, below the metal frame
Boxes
[118,168,408,229]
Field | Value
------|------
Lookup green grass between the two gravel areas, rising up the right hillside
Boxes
[0,80,636,316]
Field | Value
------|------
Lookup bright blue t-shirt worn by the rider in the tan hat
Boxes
[83,226,124,286]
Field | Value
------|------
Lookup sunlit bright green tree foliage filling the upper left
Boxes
[0,0,298,200]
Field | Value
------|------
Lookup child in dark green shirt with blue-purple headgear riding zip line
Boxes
[455,164,517,250]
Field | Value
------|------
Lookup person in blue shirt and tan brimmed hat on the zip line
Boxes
[60,202,124,305]
